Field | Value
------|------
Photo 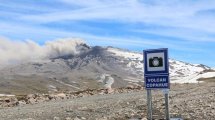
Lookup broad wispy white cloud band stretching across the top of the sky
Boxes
[17,0,215,32]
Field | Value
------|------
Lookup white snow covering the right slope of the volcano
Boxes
[108,48,215,83]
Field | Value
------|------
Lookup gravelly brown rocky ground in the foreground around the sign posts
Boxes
[0,82,215,120]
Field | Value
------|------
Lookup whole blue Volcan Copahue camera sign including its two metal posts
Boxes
[143,48,170,120]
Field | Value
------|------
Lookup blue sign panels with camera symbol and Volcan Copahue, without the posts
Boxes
[144,48,169,89]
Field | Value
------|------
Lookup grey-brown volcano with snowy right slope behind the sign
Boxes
[0,40,215,93]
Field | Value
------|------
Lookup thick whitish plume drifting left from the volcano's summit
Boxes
[0,38,85,65]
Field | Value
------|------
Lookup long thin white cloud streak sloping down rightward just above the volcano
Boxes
[0,20,177,48]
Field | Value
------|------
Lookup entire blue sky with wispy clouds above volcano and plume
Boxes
[0,0,215,67]
